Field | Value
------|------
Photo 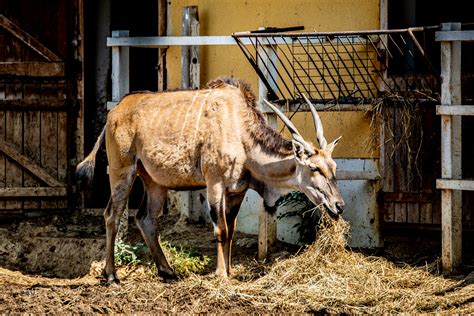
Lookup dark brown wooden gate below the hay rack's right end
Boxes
[380,102,441,229]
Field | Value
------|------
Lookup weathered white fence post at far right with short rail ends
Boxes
[435,23,474,273]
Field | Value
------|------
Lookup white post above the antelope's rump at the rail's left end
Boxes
[107,31,130,240]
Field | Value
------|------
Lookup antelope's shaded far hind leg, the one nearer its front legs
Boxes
[135,166,176,280]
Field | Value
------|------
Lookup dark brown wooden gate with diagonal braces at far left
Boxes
[0,0,82,212]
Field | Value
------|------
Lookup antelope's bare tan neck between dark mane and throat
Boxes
[247,146,296,189]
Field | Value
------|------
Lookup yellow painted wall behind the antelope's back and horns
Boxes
[167,0,379,158]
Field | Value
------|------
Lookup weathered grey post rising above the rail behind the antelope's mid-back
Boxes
[178,6,204,222]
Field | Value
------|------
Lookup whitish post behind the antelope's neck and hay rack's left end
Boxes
[257,28,278,261]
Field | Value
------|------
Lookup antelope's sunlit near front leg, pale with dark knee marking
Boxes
[207,184,228,278]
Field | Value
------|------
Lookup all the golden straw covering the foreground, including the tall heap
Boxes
[0,216,474,314]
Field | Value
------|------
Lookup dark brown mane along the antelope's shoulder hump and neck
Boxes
[206,77,292,155]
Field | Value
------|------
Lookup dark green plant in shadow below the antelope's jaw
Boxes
[278,192,320,244]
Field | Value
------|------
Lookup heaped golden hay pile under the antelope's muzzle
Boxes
[162,212,474,313]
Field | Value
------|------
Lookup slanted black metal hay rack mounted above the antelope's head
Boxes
[233,27,440,107]
